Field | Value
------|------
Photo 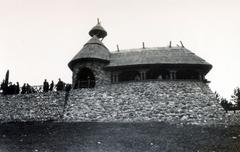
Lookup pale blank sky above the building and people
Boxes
[0,0,240,98]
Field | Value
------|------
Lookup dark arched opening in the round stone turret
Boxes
[74,67,95,89]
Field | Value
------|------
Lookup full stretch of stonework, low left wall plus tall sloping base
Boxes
[0,81,239,125]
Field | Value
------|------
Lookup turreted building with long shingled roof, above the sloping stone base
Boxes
[68,22,212,89]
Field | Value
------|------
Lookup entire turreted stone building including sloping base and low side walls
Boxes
[0,20,240,125]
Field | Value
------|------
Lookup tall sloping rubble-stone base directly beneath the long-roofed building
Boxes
[64,81,232,124]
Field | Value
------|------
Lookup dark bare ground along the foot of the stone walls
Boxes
[0,122,240,152]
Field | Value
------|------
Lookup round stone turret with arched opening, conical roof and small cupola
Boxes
[68,20,110,89]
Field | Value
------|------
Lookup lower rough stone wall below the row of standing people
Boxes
[0,92,65,122]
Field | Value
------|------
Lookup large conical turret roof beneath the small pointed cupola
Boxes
[68,35,110,69]
